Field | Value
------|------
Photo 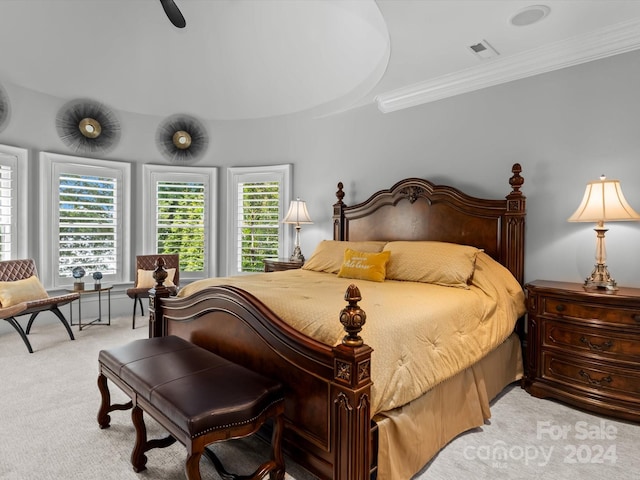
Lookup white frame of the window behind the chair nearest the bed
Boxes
[138,165,218,283]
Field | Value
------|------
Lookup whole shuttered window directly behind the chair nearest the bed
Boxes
[141,165,217,278]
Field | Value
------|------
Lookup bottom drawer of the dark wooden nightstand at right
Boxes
[542,352,640,402]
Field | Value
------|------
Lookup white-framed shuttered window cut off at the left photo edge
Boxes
[0,145,28,260]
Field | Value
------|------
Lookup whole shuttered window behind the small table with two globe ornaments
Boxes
[40,153,131,287]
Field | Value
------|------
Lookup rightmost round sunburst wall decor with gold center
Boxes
[156,115,209,163]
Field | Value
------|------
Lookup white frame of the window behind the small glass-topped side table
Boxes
[38,152,131,288]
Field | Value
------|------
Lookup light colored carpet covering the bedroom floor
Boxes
[0,317,640,480]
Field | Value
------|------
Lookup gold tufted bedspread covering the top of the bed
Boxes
[179,253,525,414]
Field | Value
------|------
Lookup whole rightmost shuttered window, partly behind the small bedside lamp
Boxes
[227,165,291,275]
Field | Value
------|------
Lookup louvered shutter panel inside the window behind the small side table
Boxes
[59,173,118,277]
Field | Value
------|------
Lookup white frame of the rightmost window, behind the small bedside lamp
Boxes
[226,164,292,275]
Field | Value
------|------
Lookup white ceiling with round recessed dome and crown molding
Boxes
[0,0,640,120]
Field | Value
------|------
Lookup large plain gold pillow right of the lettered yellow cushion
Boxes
[384,241,482,288]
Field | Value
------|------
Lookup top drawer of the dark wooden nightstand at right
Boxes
[542,297,640,327]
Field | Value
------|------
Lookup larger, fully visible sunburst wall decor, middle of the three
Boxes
[56,99,120,153]
